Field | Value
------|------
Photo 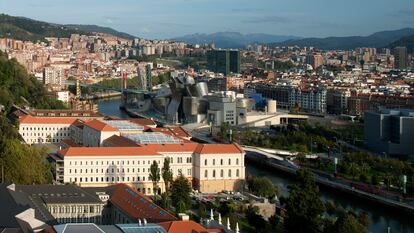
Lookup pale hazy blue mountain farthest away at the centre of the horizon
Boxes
[172,32,300,48]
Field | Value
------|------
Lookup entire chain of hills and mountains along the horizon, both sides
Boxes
[0,14,414,52]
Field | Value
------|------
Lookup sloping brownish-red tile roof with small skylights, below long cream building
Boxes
[110,184,177,223]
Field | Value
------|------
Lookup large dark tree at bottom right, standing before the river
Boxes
[285,170,325,233]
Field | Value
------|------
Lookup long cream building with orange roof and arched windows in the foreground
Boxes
[53,143,245,194]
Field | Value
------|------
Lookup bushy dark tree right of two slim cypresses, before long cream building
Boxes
[171,172,191,213]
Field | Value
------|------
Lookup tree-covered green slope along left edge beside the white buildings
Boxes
[0,52,64,184]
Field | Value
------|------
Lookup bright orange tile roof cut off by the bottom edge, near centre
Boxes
[158,221,224,233]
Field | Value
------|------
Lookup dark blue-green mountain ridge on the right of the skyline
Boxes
[272,28,414,50]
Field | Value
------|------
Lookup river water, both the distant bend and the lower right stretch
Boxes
[97,98,414,233]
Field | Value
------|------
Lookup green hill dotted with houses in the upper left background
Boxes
[0,14,133,41]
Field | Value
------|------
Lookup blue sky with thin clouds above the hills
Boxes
[0,0,414,39]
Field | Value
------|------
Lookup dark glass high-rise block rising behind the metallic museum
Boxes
[207,49,240,75]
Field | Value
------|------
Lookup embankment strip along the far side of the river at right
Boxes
[246,153,414,215]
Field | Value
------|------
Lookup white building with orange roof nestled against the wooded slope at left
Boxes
[19,115,76,145]
